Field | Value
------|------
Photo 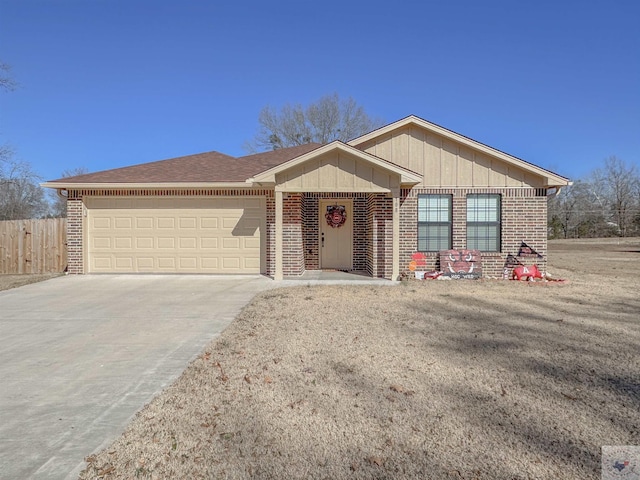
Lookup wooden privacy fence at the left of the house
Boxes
[0,218,67,274]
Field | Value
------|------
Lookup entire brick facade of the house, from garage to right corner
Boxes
[67,188,547,278]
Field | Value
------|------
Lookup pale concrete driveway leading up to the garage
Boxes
[0,275,276,479]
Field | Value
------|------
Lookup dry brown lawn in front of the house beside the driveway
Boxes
[80,239,640,480]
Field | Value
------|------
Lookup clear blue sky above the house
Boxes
[0,0,640,179]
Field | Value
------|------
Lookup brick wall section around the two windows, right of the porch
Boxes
[400,188,547,278]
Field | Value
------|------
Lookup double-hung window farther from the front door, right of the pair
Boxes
[467,194,501,252]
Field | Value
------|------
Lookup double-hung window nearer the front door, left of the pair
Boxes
[418,195,451,252]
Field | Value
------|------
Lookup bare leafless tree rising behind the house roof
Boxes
[245,93,383,152]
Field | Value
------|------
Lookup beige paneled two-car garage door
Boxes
[86,197,265,273]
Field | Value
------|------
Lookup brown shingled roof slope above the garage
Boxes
[47,143,321,186]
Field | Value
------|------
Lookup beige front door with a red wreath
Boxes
[319,199,353,270]
